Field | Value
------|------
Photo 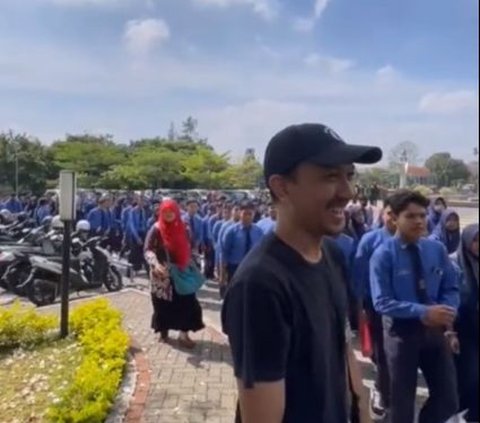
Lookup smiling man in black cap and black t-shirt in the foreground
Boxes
[222,124,382,423]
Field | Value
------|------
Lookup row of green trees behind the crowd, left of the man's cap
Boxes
[0,117,262,194]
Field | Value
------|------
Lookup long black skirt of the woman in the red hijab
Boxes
[152,289,205,332]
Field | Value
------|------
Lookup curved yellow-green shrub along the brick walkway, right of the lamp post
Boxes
[48,299,129,423]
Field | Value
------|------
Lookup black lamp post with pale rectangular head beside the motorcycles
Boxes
[59,170,77,338]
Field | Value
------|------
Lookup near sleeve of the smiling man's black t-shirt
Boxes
[222,274,291,388]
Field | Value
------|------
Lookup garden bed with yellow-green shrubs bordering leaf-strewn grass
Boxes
[0,299,129,423]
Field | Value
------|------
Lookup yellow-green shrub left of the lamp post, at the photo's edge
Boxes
[0,301,58,350]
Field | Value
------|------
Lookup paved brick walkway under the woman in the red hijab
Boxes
[102,290,236,423]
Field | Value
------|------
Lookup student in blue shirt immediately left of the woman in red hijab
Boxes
[127,197,147,272]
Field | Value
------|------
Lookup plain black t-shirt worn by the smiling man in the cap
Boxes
[222,234,348,423]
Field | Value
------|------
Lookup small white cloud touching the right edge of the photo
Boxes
[418,90,478,115]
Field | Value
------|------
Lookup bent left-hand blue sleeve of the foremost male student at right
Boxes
[370,247,427,319]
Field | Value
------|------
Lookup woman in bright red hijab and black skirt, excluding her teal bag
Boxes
[145,200,204,348]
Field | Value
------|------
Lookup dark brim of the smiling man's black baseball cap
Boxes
[309,144,383,166]
